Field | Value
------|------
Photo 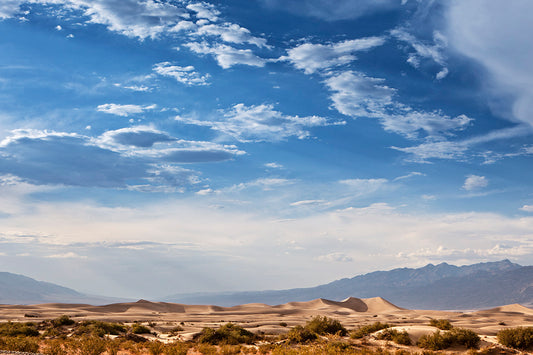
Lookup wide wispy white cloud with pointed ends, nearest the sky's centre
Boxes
[176,104,328,142]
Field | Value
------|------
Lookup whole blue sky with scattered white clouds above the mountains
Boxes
[0,0,533,299]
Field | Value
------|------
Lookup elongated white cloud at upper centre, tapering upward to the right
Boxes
[279,37,385,74]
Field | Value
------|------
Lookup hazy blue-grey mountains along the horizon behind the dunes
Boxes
[0,260,533,310]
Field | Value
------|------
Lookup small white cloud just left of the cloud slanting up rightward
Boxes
[185,42,266,69]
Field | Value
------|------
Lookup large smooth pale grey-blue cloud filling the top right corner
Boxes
[446,0,533,125]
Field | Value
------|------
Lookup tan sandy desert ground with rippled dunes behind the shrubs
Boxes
[0,297,533,354]
